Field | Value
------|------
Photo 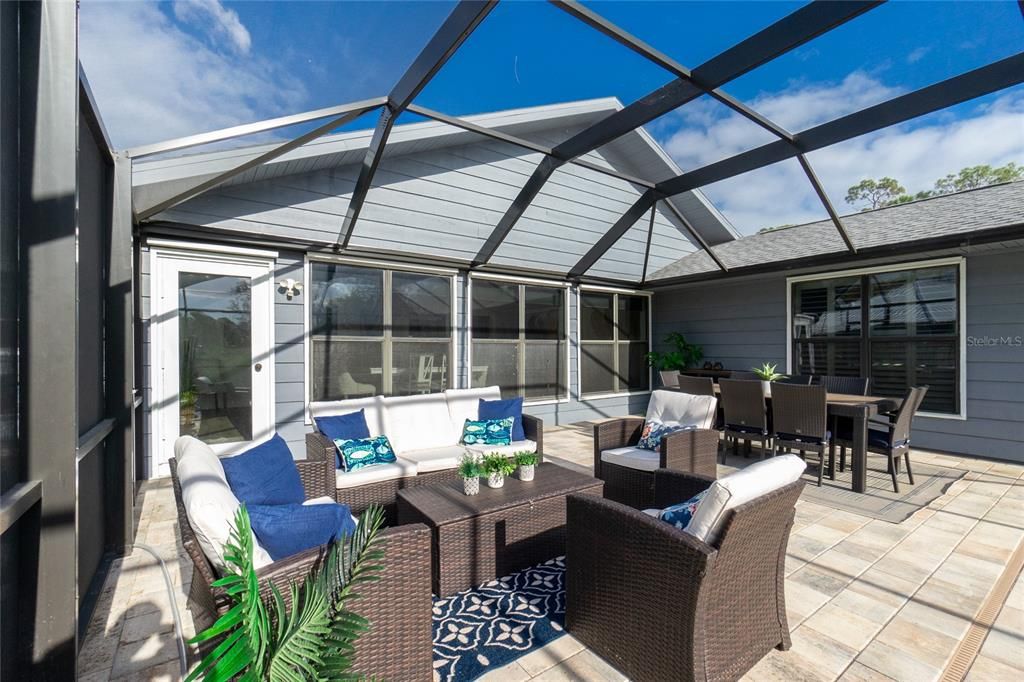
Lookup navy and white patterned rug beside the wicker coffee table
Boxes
[434,557,565,682]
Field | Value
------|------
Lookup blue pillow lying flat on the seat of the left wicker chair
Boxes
[246,503,355,561]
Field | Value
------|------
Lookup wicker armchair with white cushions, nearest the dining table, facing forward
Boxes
[594,390,719,509]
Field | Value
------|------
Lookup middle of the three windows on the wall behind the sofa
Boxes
[470,278,568,400]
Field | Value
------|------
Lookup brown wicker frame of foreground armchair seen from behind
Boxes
[565,470,804,682]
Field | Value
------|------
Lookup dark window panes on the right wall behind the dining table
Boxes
[790,263,963,415]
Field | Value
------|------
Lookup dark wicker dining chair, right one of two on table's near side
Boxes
[771,383,836,486]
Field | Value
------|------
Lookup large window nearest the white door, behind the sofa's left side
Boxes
[307,261,454,401]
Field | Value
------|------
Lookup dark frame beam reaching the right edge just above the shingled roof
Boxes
[569,52,1024,276]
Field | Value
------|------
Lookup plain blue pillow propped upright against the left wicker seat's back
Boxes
[220,433,306,506]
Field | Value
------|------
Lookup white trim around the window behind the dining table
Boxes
[785,256,967,421]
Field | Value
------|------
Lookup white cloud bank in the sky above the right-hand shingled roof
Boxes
[659,73,1024,233]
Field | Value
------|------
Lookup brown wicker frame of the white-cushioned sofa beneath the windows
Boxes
[306,415,544,523]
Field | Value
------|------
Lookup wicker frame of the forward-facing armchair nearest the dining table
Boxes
[594,417,718,509]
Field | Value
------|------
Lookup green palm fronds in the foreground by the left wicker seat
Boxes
[186,505,384,682]
